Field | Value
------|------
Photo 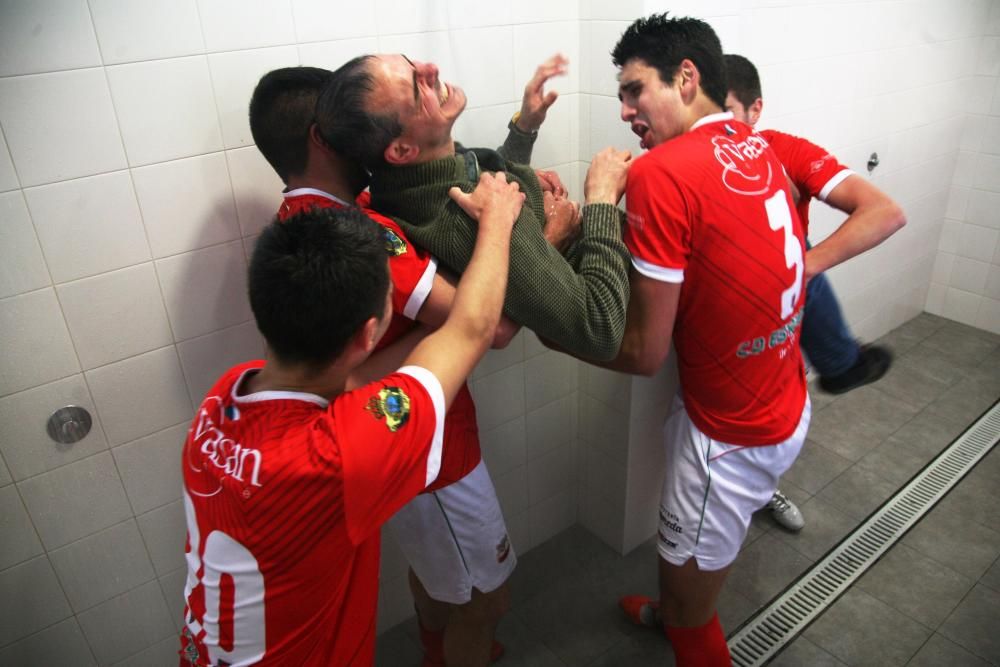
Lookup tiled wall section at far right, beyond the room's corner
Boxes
[927,3,1000,333]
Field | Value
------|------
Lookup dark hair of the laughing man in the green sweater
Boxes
[316,55,403,169]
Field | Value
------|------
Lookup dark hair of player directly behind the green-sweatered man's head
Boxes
[250,67,331,183]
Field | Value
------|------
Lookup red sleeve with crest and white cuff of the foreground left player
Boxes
[331,366,445,544]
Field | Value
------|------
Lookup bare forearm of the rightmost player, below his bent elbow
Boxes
[806,201,906,278]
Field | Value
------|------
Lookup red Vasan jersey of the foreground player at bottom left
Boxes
[181,361,444,667]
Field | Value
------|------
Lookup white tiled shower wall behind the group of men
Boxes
[0,0,1000,665]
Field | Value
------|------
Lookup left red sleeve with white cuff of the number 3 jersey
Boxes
[623,155,691,283]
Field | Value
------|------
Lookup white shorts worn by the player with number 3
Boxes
[657,395,812,570]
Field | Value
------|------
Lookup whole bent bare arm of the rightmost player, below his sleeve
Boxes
[805,174,906,280]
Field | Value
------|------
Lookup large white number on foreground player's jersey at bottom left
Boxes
[184,493,266,666]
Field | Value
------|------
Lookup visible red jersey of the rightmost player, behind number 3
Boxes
[758,130,854,236]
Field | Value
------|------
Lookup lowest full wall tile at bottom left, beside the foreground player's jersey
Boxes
[77,581,176,665]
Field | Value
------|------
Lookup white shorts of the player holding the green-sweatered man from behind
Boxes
[387,461,517,604]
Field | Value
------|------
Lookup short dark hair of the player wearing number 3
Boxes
[611,12,726,107]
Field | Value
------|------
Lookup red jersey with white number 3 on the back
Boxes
[624,113,806,445]
